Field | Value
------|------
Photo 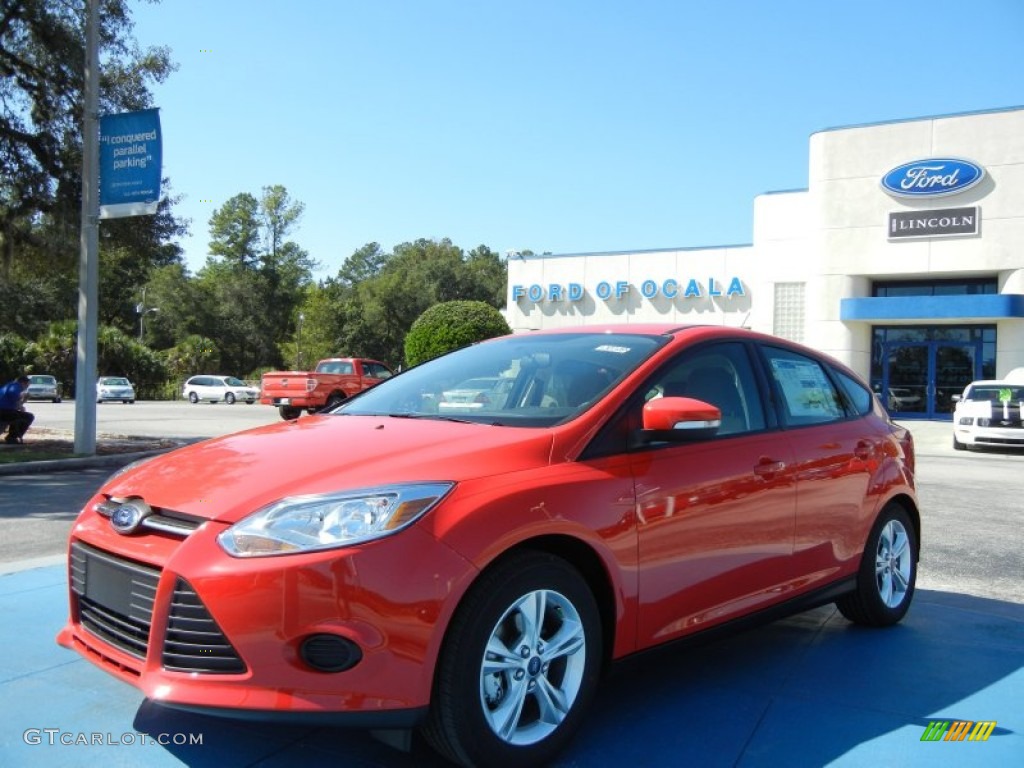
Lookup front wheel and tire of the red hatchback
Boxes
[424,552,603,768]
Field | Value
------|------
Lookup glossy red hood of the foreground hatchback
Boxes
[102,416,552,523]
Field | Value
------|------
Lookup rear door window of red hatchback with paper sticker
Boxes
[764,346,846,427]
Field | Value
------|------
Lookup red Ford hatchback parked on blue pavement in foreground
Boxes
[58,326,921,767]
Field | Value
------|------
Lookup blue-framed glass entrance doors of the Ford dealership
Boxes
[881,341,981,419]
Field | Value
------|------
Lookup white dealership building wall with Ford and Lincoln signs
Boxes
[507,109,1024,376]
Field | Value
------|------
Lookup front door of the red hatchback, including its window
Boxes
[632,342,796,645]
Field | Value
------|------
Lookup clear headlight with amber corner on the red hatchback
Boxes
[217,482,455,557]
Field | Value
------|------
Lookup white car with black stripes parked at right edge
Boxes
[953,379,1024,451]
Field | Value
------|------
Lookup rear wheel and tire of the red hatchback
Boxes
[836,504,918,627]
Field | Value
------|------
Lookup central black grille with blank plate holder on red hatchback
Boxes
[70,542,160,659]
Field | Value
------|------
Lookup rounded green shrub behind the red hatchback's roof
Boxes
[406,301,512,366]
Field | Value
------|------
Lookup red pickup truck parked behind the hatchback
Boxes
[259,357,394,420]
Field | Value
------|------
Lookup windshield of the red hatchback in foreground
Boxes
[335,333,667,427]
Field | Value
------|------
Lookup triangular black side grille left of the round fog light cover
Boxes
[163,578,246,674]
